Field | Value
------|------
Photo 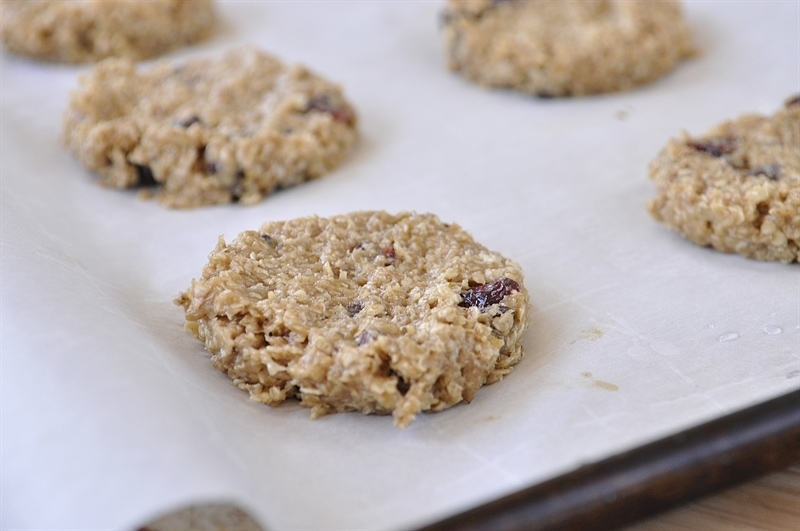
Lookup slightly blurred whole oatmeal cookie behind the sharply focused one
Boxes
[64,48,356,208]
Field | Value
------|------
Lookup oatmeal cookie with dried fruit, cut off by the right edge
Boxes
[647,98,800,262]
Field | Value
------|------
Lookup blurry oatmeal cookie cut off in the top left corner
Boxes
[0,0,215,63]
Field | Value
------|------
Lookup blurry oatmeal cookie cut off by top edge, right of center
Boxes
[442,0,692,97]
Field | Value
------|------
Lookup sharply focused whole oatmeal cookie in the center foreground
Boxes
[175,212,529,427]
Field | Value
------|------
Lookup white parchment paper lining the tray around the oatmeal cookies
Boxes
[0,1,800,529]
